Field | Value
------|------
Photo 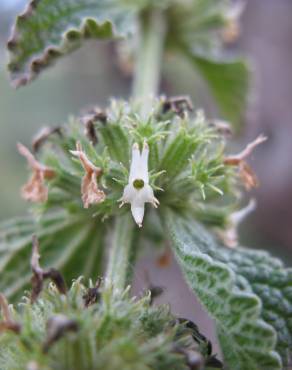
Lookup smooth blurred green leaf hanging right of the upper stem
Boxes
[189,54,249,125]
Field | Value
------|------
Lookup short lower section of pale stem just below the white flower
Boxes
[106,212,134,290]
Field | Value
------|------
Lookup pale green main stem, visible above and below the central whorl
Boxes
[106,10,165,290]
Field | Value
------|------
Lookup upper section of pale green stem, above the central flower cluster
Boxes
[133,10,165,113]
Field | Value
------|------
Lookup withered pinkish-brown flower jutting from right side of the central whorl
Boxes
[224,135,267,190]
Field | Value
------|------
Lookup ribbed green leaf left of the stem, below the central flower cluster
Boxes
[0,211,104,297]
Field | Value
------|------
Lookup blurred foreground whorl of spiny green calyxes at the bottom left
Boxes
[0,279,214,370]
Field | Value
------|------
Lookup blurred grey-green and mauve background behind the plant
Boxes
[0,0,292,350]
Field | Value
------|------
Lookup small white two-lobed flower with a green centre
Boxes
[120,142,159,227]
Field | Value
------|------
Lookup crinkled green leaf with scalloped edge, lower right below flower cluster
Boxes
[164,210,284,370]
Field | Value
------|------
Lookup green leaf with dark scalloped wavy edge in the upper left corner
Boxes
[7,0,133,86]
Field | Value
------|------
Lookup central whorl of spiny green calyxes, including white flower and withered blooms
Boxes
[16,97,265,244]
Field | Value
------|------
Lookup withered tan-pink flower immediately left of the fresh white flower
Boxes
[70,142,106,208]
